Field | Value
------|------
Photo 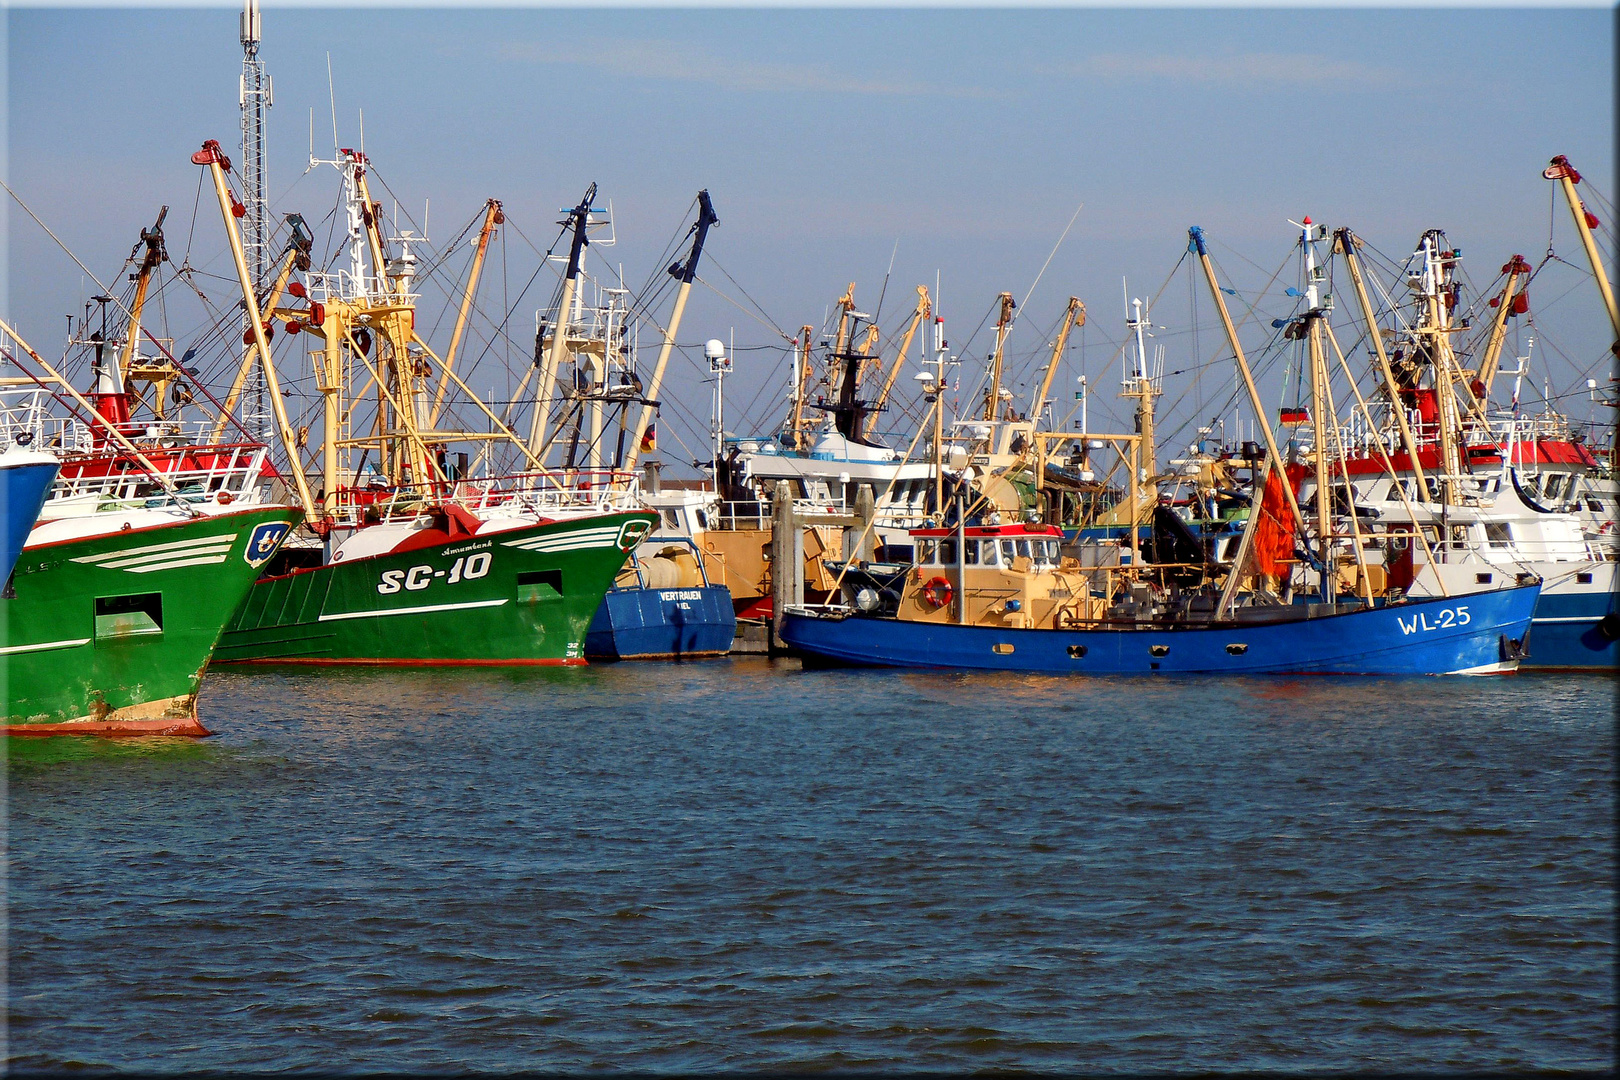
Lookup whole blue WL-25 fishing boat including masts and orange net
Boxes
[781,219,1541,675]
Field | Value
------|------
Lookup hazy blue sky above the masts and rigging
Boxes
[3,5,1615,459]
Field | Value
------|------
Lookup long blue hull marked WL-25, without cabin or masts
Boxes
[781,585,1541,675]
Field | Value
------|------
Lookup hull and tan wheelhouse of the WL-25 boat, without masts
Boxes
[781,525,1541,675]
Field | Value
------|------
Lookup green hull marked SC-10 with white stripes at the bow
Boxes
[215,512,654,667]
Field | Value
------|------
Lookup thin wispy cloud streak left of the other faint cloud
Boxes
[499,40,988,97]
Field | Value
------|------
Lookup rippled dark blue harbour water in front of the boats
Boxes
[6,659,1615,1070]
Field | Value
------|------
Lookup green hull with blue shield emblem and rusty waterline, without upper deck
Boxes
[0,507,300,735]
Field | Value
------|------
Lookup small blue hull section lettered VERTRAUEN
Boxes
[585,585,737,661]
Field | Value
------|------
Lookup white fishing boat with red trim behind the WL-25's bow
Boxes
[1301,220,1620,670]
